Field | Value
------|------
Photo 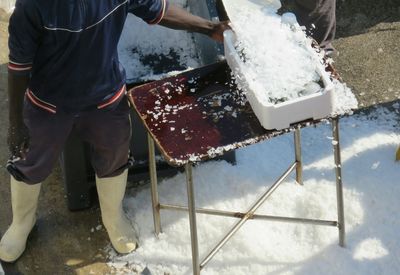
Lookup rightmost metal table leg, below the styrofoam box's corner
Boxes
[332,117,346,247]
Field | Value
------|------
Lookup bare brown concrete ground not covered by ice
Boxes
[0,0,400,274]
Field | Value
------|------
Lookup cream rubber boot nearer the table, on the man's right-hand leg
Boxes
[96,170,137,254]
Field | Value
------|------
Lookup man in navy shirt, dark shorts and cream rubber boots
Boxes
[0,0,227,262]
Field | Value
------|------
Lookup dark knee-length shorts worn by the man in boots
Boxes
[7,96,131,184]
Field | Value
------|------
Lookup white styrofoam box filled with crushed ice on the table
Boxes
[224,30,334,130]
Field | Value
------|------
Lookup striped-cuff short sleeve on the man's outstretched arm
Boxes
[129,0,168,24]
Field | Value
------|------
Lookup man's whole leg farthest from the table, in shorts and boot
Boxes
[0,99,72,262]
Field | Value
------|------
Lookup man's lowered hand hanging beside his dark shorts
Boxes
[7,123,29,158]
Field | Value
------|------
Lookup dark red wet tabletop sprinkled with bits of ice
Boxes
[128,62,332,166]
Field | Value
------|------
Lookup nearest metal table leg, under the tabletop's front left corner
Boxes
[185,163,200,275]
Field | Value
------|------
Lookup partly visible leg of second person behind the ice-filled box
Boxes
[294,0,336,52]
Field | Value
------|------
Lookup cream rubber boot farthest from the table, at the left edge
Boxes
[0,177,42,262]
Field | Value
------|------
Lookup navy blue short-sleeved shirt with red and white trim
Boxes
[8,0,168,113]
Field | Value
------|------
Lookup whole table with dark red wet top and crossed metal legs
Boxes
[128,62,345,274]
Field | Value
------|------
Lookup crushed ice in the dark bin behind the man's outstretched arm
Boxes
[118,0,201,83]
